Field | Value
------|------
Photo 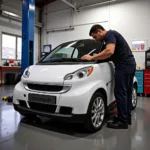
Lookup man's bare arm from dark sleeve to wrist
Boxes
[92,43,116,60]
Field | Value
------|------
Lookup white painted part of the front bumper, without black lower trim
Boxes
[13,82,98,115]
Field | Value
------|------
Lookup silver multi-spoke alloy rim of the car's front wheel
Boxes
[91,97,105,128]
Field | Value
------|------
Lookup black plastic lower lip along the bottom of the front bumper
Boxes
[13,104,86,123]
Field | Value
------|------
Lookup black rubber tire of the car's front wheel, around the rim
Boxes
[85,92,107,133]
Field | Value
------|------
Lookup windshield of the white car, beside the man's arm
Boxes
[40,40,102,63]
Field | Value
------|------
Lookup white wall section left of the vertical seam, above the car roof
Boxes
[42,1,109,48]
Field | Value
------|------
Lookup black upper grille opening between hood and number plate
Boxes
[27,83,63,92]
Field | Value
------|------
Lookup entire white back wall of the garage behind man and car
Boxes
[42,0,150,68]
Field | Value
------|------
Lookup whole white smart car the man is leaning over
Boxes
[13,39,137,132]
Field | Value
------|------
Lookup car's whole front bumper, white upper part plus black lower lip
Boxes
[13,77,107,122]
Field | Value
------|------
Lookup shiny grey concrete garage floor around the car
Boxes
[0,86,150,150]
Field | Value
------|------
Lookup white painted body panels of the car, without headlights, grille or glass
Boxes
[13,63,117,114]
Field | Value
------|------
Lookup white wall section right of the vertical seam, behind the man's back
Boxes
[110,0,150,69]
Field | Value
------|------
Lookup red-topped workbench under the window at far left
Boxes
[0,66,21,86]
